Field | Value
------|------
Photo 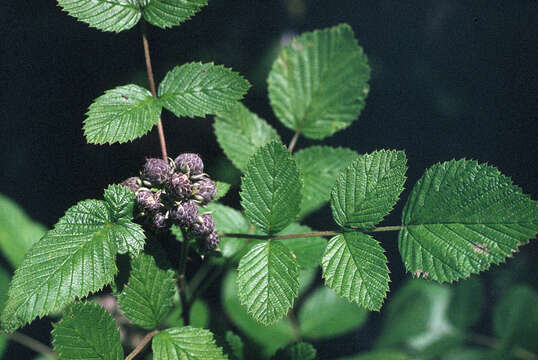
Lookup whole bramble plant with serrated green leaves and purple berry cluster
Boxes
[1,0,538,359]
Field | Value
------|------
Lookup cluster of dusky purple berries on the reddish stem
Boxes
[121,153,219,250]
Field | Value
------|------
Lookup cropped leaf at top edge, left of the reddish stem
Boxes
[58,0,142,32]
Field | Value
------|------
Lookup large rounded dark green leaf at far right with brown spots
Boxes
[398,160,538,282]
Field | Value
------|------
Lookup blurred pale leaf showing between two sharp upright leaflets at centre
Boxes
[294,146,357,217]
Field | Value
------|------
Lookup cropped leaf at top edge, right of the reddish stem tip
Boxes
[143,0,207,29]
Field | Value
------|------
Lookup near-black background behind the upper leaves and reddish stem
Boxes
[0,0,538,354]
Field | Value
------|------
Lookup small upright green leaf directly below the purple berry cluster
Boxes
[118,253,176,330]
